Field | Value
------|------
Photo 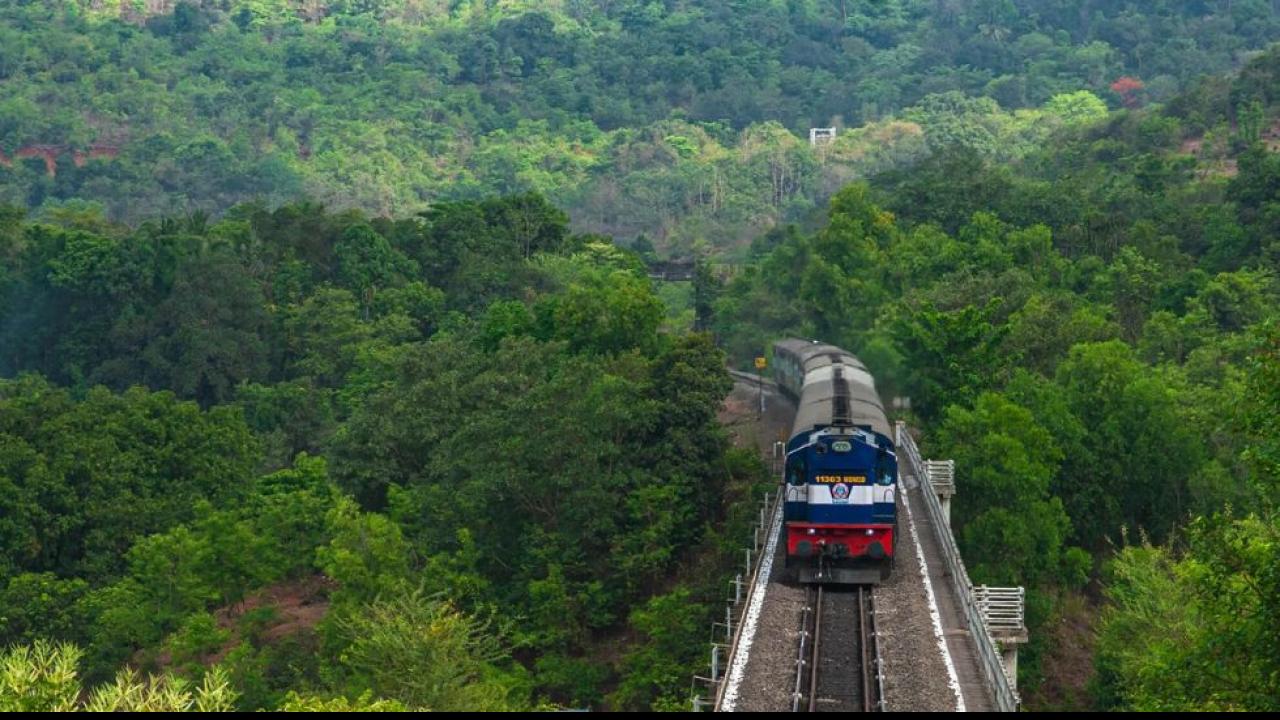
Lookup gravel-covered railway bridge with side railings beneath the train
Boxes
[692,373,1027,712]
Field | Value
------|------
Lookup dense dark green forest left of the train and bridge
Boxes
[0,195,758,710]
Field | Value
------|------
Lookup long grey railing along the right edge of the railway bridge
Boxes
[897,421,1021,712]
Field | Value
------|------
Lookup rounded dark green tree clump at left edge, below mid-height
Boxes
[0,378,257,582]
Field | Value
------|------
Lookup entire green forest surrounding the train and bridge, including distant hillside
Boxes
[0,0,1280,711]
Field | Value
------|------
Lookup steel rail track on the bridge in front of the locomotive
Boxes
[791,585,884,712]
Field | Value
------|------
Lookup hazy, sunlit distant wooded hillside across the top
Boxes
[0,0,1280,250]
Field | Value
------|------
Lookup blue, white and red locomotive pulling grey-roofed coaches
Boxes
[773,338,897,585]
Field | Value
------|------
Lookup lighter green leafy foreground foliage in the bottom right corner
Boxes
[1097,323,1280,711]
